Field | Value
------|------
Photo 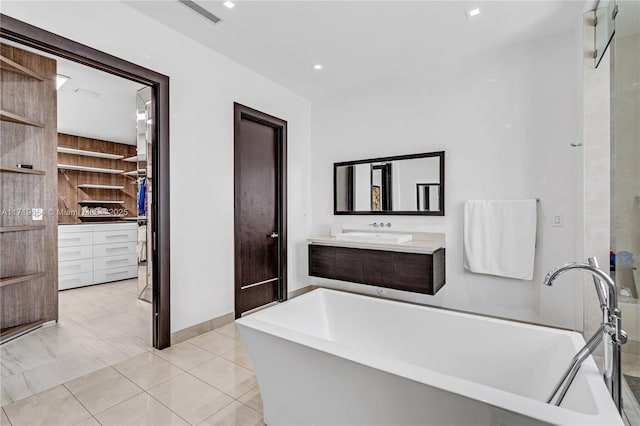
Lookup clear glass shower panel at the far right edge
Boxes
[611,0,640,424]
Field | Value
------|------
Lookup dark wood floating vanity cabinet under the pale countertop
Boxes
[309,244,445,295]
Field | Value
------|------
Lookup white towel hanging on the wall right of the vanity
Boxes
[464,199,537,280]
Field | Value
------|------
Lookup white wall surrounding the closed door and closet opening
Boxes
[2,1,311,331]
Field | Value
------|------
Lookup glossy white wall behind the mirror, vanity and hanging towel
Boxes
[309,33,582,330]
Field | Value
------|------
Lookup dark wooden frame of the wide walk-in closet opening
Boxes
[0,14,171,349]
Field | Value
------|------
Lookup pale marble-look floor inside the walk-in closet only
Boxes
[0,279,151,406]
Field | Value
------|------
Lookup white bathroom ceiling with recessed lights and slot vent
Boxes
[124,0,593,100]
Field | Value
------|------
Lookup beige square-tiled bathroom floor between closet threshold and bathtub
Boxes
[0,324,264,426]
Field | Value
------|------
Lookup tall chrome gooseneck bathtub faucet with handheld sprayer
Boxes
[543,257,627,413]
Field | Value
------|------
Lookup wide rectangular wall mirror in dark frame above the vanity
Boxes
[333,151,444,216]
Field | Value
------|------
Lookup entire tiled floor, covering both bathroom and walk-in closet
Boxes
[0,281,264,426]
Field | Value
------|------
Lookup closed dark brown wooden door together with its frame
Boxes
[234,104,286,318]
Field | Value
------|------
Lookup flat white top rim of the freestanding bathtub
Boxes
[236,288,623,426]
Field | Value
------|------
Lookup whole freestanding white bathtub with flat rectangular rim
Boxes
[236,289,623,426]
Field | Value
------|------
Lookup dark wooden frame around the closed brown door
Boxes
[233,102,288,319]
